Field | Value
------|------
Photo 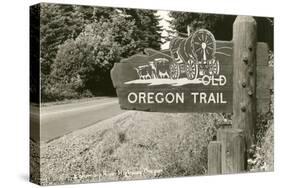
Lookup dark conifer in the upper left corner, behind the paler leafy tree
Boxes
[40,3,96,91]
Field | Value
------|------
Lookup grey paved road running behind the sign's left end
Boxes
[30,98,124,142]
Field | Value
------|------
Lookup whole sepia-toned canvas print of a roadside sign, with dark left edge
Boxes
[29,3,275,185]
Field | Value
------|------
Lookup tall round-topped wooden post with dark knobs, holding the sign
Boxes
[233,16,257,148]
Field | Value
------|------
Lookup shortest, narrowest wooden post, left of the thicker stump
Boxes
[208,141,222,175]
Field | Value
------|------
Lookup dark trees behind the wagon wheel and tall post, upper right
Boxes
[170,12,273,49]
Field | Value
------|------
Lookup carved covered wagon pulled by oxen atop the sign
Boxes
[132,29,220,80]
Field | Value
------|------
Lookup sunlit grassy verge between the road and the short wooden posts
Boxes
[40,111,222,185]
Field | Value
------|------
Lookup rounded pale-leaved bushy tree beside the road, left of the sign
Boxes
[44,15,135,99]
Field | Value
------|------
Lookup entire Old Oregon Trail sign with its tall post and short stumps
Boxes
[111,16,273,174]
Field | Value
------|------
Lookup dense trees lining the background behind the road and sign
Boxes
[31,3,273,102]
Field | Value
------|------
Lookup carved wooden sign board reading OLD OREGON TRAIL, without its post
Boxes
[111,29,272,112]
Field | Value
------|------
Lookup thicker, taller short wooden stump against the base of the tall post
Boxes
[217,128,246,174]
